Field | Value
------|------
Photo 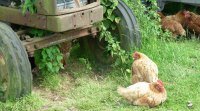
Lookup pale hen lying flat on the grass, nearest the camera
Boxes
[117,80,167,107]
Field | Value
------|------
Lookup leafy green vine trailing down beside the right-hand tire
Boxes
[99,0,129,66]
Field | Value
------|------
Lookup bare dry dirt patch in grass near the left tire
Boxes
[33,72,74,111]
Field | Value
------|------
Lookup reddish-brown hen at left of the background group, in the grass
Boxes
[158,11,188,37]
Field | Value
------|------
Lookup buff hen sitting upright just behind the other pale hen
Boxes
[131,52,158,84]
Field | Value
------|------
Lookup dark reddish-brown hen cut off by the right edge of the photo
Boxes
[187,12,200,35]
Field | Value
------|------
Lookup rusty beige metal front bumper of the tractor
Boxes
[0,0,103,32]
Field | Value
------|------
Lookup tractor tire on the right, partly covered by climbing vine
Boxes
[115,0,141,51]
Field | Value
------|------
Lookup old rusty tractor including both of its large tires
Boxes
[0,0,140,101]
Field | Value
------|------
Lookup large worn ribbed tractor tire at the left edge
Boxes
[0,22,32,101]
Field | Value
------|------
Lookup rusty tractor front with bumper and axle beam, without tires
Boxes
[0,0,103,56]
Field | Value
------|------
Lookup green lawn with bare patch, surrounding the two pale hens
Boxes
[0,40,200,111]
